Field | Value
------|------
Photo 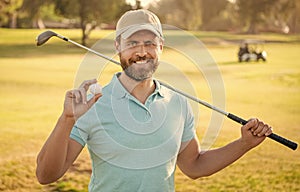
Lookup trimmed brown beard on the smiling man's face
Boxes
[120,55,159,81]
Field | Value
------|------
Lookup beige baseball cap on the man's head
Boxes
[116,9,163,39]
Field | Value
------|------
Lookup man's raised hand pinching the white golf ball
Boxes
[62,79,102,121]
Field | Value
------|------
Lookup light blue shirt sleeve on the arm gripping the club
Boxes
[181,100,196,142]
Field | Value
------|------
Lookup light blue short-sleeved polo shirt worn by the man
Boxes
[70,74,195,192]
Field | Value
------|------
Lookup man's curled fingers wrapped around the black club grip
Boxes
[247,119,272,137]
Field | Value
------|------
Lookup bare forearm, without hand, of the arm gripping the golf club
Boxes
[190,139,250,179]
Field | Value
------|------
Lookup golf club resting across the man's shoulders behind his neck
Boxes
[36,31,298,150]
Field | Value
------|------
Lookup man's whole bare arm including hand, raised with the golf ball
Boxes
[36,79,102,184]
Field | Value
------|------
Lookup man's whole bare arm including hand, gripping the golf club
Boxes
[177,119,272,179]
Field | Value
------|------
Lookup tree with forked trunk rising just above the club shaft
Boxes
[55,0,131,45]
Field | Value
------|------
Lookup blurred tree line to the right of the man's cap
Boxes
[150,0,300,33]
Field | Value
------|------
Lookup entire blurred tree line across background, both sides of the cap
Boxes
[0,0,300,44]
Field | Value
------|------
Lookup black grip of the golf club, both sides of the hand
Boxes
[227,113,298,150]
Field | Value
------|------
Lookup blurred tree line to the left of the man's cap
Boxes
[0,0,132,45]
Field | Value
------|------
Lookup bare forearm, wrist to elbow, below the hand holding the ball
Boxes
[36,115,75,183]
